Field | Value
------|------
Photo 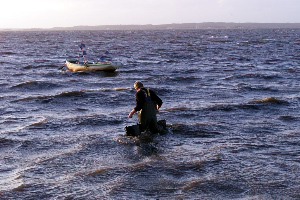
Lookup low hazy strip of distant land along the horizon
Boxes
[0,22,300,31]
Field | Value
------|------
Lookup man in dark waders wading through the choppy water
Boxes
[128,81,163,133]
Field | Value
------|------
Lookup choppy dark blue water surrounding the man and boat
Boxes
[0,29,300,200]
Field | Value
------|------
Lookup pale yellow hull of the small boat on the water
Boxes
[66,60,121,72]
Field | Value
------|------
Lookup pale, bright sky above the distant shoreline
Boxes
[0,0,300,29]
